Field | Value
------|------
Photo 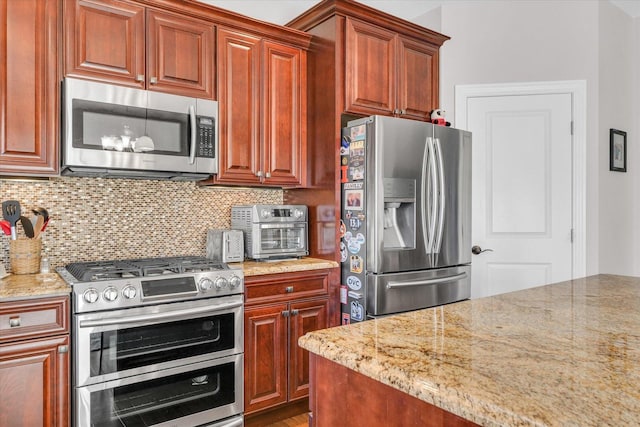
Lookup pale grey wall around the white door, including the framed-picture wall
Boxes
[414,0,639,274]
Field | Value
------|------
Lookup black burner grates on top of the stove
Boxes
[66,256,229,282]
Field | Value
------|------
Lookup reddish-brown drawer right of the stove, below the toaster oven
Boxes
[245,272,329,303]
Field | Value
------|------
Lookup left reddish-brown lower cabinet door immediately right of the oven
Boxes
[244,304,289,414]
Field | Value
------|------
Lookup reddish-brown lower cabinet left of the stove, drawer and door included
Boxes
[0,298,70,427]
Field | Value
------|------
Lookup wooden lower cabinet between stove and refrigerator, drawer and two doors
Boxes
[244,268,340,427]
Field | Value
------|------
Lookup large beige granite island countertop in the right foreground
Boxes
[299,275,640,426]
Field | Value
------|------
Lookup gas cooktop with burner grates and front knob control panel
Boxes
[56,256,244,313]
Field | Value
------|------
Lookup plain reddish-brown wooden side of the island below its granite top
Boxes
[309,354,477,427]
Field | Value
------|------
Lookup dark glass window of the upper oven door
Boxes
[90,313,237,377]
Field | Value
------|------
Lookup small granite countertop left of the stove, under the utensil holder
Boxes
[0,273,71,302]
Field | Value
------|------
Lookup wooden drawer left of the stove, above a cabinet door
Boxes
[0,297,69,343]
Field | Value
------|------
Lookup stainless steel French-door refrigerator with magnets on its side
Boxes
[340,116,471,324]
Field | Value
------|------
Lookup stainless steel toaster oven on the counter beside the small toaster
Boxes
[231,205,309,260]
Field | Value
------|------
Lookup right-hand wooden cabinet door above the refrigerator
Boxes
[398,37,438,121]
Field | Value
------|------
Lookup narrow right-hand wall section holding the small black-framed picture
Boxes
[598,2,640,275]
